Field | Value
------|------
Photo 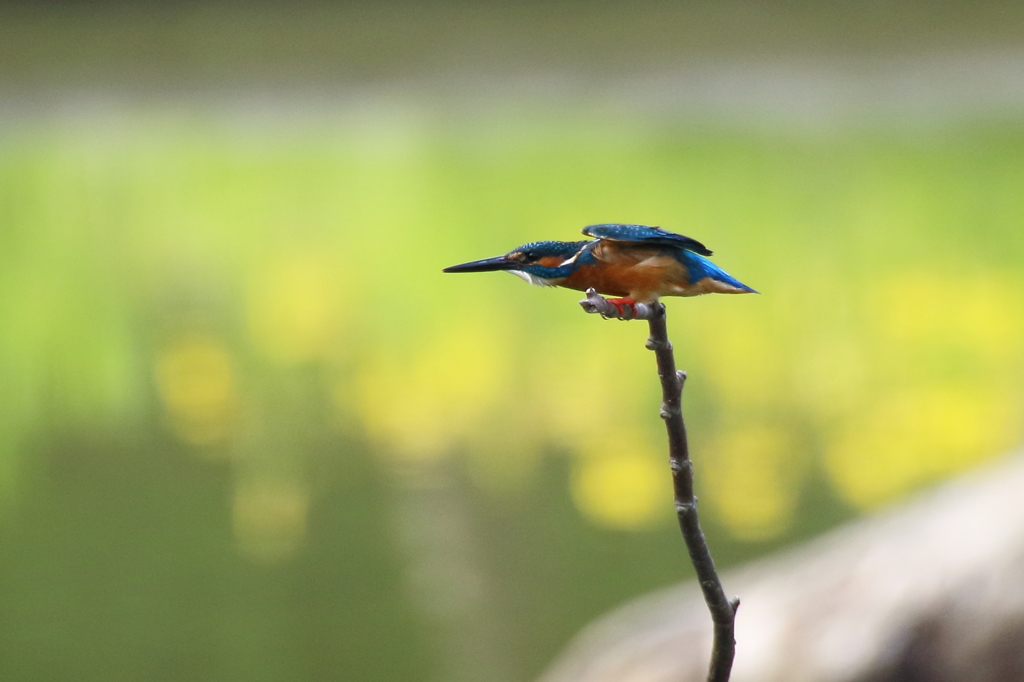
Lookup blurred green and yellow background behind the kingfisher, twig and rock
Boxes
[0,1,1024,682]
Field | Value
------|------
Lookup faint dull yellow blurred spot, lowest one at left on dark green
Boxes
[231,479,309,562]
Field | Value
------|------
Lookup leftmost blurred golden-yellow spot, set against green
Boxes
[155,336,237,445]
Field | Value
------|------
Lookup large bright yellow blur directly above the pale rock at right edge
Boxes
[826,386,1022,508]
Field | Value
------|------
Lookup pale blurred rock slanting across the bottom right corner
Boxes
[540,448,1024,682]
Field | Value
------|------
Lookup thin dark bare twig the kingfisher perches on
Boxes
[580,289,739,682]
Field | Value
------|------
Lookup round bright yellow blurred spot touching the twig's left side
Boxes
[570,450,672,530]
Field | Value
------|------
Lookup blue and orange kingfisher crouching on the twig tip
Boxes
[443,223,758,311]
